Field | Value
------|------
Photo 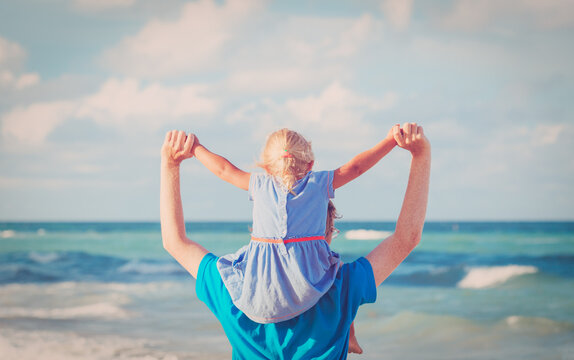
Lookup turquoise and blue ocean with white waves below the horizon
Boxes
[0,222,574,360]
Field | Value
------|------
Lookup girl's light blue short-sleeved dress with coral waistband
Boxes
[217,171,340,323]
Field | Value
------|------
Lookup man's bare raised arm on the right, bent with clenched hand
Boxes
[366,123,431,286]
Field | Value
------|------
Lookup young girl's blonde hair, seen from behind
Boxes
[257,129,315,191]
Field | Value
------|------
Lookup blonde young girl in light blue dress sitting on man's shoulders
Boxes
[192,129,399,340]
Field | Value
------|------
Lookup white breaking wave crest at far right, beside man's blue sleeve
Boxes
[457,265,538,289]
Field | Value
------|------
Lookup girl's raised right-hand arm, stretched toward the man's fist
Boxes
[333,125,400,189]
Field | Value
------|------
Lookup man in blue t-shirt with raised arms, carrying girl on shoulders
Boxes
[160,123,431,359]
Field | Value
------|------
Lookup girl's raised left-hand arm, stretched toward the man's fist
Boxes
[191,137,251,190]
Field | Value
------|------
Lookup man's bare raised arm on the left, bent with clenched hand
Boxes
[160,131,208,278]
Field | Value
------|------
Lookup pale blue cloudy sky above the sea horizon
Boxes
[0,0,574,221]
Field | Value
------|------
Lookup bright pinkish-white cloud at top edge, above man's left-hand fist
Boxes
[103,0,261,78]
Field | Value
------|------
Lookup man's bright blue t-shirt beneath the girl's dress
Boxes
[195,254,377,360]
